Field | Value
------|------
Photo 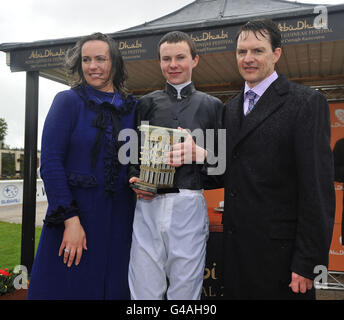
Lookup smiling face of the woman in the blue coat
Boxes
[81,40,114,92]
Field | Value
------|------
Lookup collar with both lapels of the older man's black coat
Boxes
[228,75,289,145]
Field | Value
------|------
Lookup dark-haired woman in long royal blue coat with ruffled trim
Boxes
[28,33,136,299]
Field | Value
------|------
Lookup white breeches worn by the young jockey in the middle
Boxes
[129,189,209,300]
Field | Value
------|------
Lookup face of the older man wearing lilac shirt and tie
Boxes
[236,31,282,88]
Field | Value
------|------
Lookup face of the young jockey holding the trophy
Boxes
[160,41,199,84]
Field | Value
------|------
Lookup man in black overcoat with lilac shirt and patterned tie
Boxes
[223,21,335,299]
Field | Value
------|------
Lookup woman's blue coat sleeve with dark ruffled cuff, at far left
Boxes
[40,90,81,226]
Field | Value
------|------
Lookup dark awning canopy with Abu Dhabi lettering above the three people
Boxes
[0,0,344,100]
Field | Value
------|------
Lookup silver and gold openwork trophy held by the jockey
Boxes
[132,125,187,193]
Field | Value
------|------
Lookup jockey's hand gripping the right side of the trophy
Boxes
[167,127,207,167]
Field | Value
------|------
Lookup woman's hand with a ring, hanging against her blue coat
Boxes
[59,216,87,267]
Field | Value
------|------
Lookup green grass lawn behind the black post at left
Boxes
[0,221,42,270]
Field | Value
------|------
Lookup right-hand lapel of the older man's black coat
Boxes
[234,76,289,145]
